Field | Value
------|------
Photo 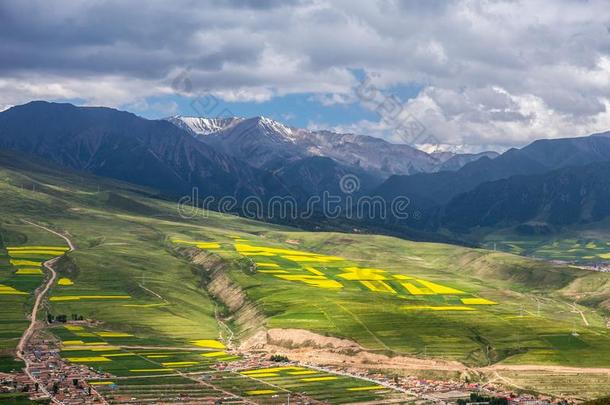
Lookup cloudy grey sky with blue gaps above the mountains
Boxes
[0,0,610,152]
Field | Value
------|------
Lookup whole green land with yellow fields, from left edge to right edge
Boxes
[0,151,610,403]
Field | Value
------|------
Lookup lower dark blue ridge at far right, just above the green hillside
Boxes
[443,161,610,232]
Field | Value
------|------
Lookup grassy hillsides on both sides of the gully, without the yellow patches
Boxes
[0,148,610,366]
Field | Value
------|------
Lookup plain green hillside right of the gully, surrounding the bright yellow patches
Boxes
[201,232,608,365]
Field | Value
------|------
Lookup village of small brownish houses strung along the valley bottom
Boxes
[0,326,551,405]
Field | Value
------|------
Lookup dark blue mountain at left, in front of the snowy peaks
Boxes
[0,101,288,198]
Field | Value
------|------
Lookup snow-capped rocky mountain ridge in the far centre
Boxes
[167,116,497,179]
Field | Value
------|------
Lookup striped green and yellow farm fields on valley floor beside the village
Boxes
[51,324,397,404]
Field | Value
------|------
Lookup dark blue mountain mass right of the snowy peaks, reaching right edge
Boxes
[372,132,610,235]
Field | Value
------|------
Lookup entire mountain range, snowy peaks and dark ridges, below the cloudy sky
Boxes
[0,101,610,241]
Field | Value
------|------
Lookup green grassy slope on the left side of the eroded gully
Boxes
[0,151,223,348]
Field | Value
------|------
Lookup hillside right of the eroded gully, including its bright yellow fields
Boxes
[173,232,608,366]
